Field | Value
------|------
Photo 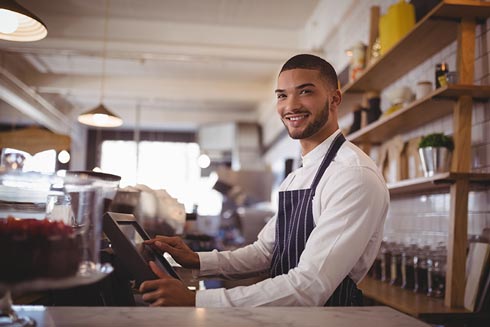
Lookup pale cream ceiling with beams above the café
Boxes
[0,0,348,130]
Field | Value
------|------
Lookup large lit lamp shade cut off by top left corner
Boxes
[0,0,48,42]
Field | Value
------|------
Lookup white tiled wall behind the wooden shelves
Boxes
[267,0,490,244]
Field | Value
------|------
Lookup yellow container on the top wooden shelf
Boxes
[379,0,415,54]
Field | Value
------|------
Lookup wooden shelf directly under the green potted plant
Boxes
[388,173,490,196]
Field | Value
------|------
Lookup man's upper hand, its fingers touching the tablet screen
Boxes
[145,236,200,269]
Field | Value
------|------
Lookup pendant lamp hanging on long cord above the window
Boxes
[78,0,123,127]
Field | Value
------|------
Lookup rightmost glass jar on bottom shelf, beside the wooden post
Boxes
[427,251,446,298]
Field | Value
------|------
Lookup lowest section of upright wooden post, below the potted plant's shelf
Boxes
[444,179,469,308]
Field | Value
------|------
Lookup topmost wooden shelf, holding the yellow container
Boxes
[339,0,490,116]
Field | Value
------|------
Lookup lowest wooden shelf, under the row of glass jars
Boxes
[358,276,484,321]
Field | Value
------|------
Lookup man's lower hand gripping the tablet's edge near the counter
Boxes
[140,261,196,307]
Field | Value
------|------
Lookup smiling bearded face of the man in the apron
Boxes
[276,69,330,139]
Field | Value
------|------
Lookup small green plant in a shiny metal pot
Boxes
[419,133,454,177]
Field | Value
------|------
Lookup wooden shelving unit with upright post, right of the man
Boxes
[340,0,490,314]
